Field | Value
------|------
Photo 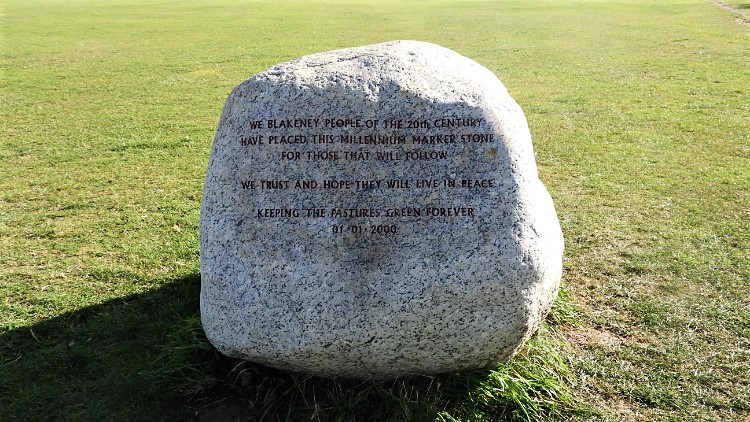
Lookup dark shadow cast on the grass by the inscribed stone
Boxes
[0,274,506,421]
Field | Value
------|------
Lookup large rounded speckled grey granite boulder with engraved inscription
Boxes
[200,41,563,378]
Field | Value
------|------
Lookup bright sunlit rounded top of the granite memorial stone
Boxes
[248,40,508,107]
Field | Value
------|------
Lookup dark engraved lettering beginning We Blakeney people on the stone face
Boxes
[237,116,497,235]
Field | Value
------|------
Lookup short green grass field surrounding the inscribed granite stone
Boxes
[0,0,750,421]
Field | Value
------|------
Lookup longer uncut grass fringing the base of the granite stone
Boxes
[137,292,593,421]
